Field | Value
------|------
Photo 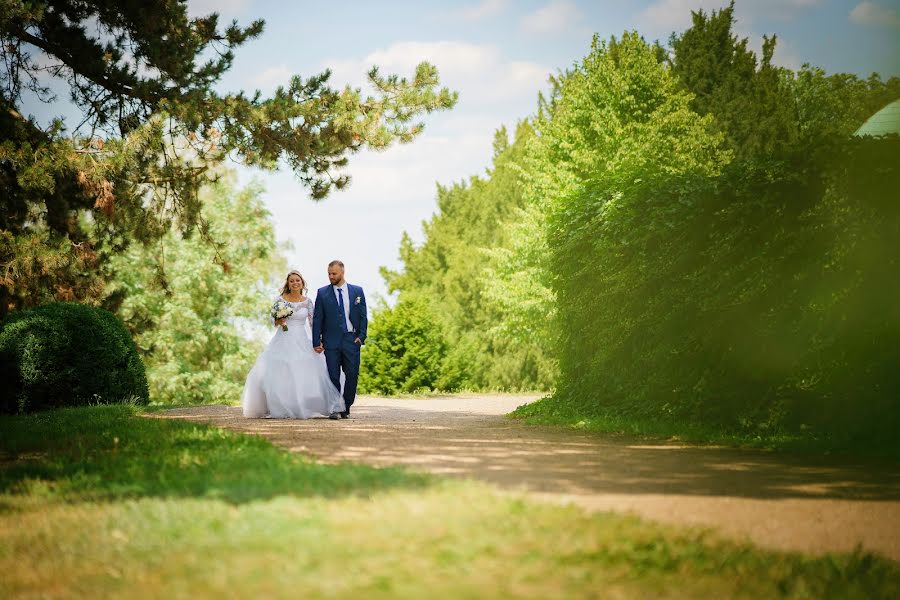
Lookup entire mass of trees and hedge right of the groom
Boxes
[360,5,900,448]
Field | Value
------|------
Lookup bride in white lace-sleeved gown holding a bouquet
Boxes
[241,271,345,419]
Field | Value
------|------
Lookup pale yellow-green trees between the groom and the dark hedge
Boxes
[380,122,555,390]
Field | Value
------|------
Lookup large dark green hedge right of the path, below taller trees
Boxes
[554,131,900,445]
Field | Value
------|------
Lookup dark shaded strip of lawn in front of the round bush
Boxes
[0,406,431,503]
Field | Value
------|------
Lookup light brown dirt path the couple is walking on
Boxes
[158,396,900,560]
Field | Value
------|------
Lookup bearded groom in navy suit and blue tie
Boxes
[313,260,369,419]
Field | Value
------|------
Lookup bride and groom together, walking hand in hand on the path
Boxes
[241,260,368,419]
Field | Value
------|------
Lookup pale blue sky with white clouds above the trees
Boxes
[17,0,900,305]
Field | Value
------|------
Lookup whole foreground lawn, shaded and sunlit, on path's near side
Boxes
[0,407,900,599]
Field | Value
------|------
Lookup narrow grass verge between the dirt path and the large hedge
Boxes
[510,398,900,460]
